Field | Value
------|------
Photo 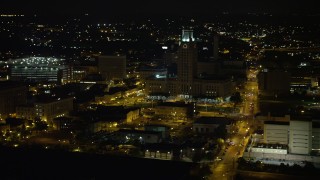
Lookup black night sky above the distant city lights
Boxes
[0,0,320,14]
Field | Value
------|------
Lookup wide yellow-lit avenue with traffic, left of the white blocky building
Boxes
[207,67,259,180]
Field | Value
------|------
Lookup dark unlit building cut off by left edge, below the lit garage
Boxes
[0,81,28,119]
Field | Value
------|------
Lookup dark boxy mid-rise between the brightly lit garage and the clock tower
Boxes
[98,55,126,80]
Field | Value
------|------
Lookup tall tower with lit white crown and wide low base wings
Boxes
[146,30,234,98]
